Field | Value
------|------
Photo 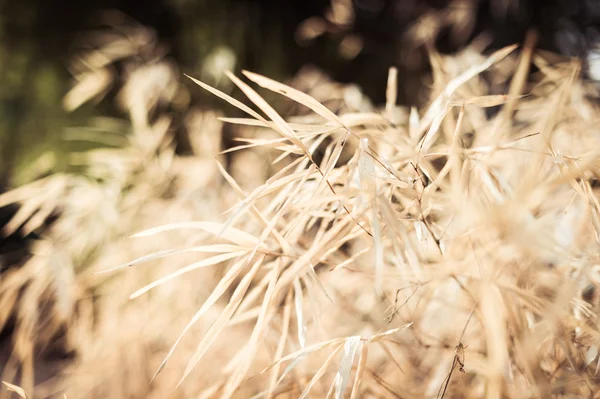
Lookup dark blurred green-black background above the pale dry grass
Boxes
[0,0,600,187]
